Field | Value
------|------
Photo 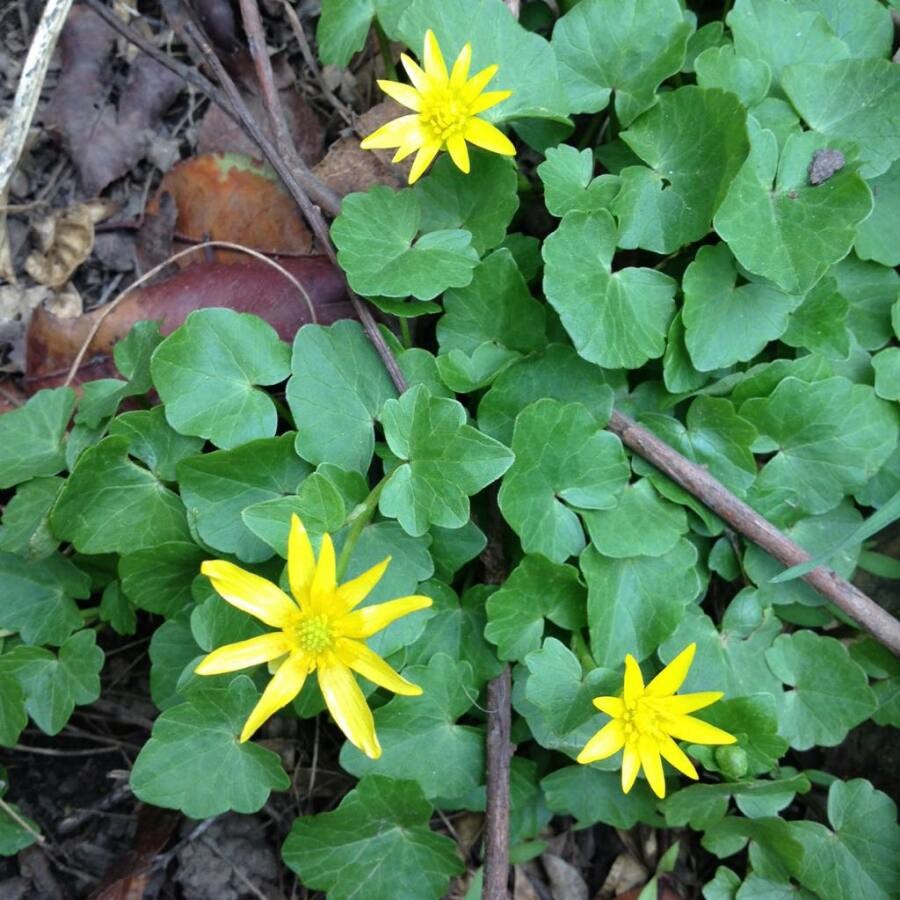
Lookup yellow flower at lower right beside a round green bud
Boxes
[578,644,737,797]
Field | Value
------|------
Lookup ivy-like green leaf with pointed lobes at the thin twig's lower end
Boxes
[379,385,513,536]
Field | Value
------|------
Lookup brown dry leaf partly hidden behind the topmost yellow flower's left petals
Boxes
[312,100,412,196]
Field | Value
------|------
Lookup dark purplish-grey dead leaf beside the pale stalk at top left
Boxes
[44,6,184,195]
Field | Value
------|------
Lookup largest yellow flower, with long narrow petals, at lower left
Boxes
[194,516,431,759]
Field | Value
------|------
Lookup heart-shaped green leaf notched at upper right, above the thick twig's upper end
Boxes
[543,210,676,369]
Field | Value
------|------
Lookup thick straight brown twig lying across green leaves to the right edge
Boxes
[606,411,900,656]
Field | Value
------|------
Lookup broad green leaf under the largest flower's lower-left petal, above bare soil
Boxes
[131,675,290,819]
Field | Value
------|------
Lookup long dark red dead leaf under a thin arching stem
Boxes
[25,256,353,393]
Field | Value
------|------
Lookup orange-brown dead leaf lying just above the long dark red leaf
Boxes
[147,153,312,265]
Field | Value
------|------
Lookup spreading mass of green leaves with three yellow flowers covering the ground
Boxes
[0,0,900,900]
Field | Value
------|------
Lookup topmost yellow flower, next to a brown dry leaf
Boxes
[360,29,516,184]
